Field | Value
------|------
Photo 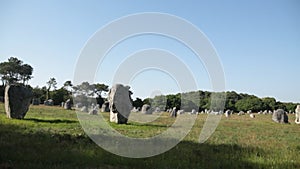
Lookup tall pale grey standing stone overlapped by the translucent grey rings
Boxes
[108,84,132,124]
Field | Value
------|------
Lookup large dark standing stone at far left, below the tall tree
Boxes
[5,85,33,119]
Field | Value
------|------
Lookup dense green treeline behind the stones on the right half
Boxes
[147,91,297,112]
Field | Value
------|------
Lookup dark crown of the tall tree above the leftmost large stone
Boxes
[0,57,33,85]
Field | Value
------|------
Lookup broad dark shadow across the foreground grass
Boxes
[0,121,300,169]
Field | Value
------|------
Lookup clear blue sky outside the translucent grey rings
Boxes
[0,0,300,102]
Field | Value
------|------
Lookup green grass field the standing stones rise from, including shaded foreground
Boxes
[0,104,300,169]
